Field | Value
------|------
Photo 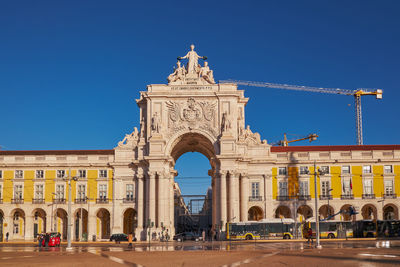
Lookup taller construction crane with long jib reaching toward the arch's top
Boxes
[219,80,383,145]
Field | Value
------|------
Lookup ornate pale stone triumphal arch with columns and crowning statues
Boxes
[114,45,270,240]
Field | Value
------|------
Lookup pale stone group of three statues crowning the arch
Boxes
[167,45,215,85]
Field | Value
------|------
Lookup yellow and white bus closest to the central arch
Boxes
[226,219,295,240]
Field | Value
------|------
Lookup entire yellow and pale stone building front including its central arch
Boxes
[0,46,400,243]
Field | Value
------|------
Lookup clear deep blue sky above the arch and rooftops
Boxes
[0,0,400,196]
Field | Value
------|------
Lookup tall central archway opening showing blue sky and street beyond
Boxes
[171,133,215,236]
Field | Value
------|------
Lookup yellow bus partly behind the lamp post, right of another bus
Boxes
[302,221,353,239]
